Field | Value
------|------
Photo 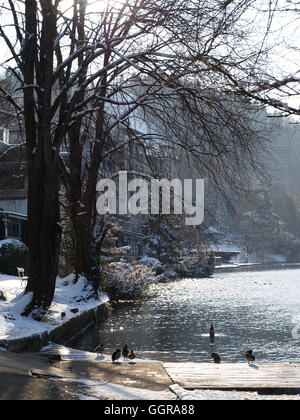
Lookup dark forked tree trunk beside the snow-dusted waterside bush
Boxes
[62,105,107,292]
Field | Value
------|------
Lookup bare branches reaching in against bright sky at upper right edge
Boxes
[230,0,300,118]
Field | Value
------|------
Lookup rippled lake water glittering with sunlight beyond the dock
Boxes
[71,266,300,362]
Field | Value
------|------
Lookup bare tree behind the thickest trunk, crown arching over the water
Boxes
[55,0,268,286]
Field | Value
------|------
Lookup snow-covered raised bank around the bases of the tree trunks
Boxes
[0,274,108,340]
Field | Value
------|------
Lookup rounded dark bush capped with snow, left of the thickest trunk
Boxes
[0,239,28,276]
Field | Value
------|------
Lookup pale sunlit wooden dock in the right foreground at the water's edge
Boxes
[163,362,300,390]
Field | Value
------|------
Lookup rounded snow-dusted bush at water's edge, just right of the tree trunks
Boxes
[102,262,160,300]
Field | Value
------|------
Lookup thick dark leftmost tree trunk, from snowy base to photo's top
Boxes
[21,0,61,319]
